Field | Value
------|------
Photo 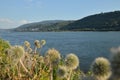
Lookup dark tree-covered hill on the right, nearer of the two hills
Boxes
[61,11,120,31]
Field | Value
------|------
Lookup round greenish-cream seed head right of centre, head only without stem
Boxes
[65,53,79,70]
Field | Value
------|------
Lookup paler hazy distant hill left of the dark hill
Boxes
[14,20,73,31]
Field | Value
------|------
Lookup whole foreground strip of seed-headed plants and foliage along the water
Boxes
[0,39,120,80]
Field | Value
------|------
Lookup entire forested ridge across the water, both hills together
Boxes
[15,11,120,31]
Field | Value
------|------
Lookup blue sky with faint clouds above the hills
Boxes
[0,0,120,29]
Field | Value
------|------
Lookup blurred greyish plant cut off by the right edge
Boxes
[110,47,120,80]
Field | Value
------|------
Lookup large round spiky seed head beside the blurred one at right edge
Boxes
[91,57,111,80]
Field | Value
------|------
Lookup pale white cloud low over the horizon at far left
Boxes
[0,18,28,29]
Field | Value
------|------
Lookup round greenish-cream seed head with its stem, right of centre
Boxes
[65,53,79,80]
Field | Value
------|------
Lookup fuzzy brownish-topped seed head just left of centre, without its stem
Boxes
[47,48,61,63]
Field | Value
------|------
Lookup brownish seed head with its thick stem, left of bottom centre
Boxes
[46,48,61,80]
